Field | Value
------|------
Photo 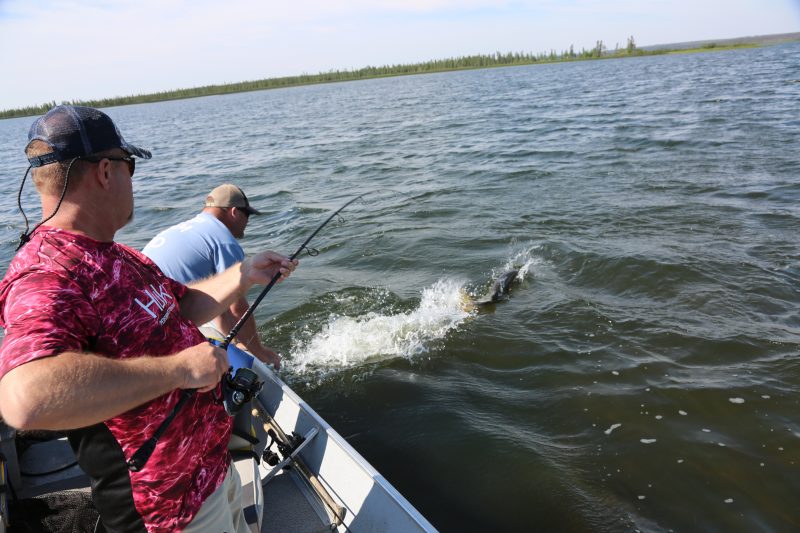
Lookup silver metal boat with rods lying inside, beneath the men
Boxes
[0,361,435,533]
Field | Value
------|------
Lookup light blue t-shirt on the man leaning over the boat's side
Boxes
[142,213,244,284]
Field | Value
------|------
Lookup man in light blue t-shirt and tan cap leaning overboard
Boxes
[142,183,280,368]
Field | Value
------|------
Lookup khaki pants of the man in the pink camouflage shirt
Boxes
[183,463,250,533]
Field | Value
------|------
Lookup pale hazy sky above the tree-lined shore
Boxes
[0,0,800,109]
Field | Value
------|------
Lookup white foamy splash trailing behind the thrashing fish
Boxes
[286,280,470,374]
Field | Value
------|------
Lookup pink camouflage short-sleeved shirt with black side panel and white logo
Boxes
[0,226,231,533]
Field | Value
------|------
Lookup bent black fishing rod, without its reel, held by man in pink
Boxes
[127,193,368,472]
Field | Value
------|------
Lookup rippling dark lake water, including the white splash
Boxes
[0,43,800,532]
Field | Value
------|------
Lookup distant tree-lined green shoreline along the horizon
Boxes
[0,33,800,119]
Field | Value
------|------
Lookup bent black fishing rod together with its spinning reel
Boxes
[127,193,368,472]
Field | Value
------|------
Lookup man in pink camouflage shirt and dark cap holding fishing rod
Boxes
[0,105,297,533]
